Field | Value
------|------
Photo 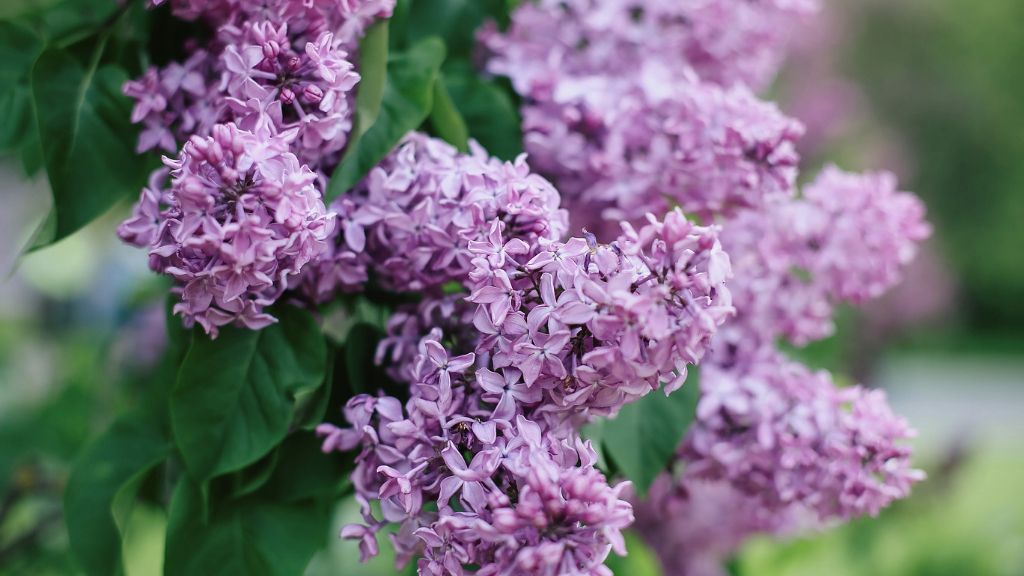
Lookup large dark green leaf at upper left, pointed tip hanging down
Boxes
[32,39,151,242]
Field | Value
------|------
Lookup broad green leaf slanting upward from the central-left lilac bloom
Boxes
[327,38,444,202]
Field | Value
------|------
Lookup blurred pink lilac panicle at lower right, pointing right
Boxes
[682,353,923,521]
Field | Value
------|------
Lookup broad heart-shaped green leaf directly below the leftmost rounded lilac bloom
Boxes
[171,307,327,482]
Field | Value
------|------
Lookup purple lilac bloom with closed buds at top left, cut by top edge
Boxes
[130,0,394,171]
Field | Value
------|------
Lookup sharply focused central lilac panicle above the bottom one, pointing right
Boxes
[467,210,732,427]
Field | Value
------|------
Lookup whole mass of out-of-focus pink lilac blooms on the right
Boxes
[481,0,929,574]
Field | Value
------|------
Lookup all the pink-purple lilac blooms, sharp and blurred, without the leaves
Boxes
[119,0,929,576]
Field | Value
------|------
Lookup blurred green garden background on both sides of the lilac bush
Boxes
[0,0,1024,576]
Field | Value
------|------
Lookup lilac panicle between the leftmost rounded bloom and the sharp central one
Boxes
[306,132,567,300]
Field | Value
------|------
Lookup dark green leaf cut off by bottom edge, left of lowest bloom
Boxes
[164,469,331,576]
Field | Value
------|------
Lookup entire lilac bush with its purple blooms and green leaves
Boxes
[2,0,930,576]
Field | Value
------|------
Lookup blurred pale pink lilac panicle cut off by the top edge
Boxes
[484,0,818,95]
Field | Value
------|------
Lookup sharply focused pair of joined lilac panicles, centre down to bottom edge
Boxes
[318,211,732,575]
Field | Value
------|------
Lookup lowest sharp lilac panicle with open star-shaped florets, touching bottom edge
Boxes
[317,337,633,576]
